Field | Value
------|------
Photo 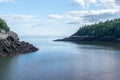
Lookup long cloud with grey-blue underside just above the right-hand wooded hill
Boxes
[48,9,120,25]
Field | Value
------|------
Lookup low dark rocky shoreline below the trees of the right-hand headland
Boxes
[54,36,120,43]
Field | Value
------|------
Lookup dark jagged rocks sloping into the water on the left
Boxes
[0,31,38,56]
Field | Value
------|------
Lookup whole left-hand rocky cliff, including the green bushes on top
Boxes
[0,18,38,56]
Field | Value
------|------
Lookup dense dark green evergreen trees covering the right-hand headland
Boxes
[74,19,120,37]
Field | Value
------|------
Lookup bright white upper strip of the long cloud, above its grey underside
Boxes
[65,9,120,19]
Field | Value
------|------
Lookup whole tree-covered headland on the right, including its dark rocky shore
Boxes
[55,19,120,43]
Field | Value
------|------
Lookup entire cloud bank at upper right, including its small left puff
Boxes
[49,0,120,25]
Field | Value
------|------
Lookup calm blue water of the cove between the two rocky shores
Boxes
[0,37,120,80]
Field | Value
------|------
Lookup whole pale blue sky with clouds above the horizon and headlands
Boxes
[0,0,120,36]
